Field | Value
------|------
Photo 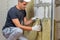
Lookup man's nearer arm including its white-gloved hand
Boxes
[12,18,41,31]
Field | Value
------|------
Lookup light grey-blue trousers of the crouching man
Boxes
[2,27,28,40]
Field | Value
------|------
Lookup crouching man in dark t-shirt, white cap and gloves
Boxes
[2,0,40,40]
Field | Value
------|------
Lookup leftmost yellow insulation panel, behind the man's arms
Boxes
[24,0,37,40]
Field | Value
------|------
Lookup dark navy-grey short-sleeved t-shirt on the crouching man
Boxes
[2,6,26,30]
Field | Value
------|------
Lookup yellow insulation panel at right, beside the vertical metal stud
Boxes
[42,18,51,40]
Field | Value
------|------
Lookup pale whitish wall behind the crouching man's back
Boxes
[0,0,17,40]
